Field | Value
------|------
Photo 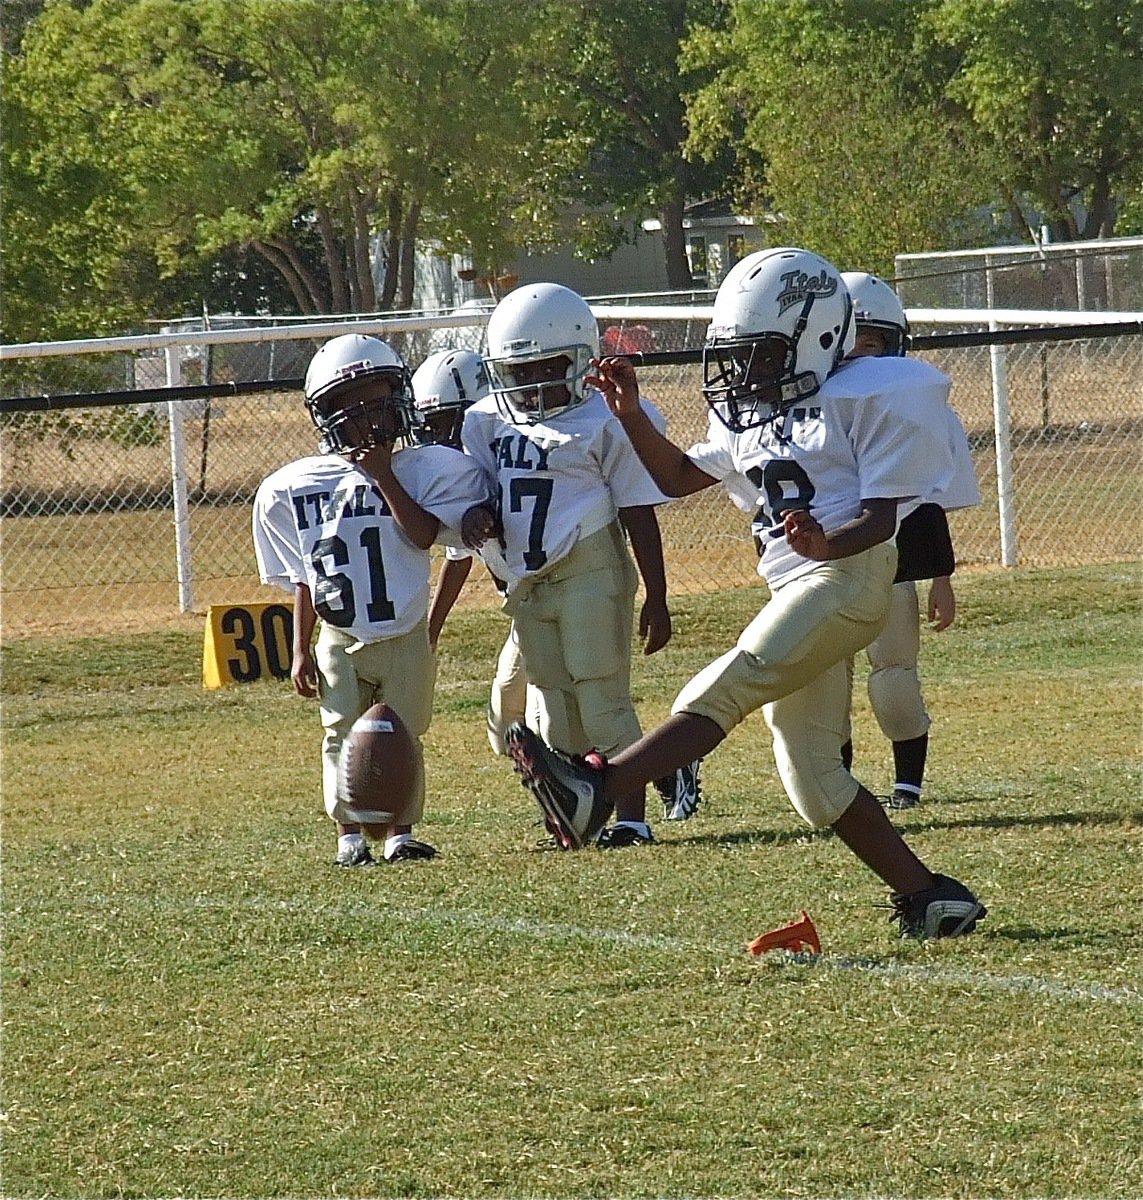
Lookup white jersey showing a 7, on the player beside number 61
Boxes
[461,391,666,592]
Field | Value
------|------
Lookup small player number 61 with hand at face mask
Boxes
[253,334,487,866]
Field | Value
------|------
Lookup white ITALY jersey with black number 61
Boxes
[253,445,487,642]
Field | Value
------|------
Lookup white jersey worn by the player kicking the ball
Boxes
[687,358,953,587]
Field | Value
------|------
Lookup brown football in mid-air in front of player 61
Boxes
[337,704,417,826]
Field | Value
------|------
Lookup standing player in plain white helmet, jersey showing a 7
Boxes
[461,283,675,848]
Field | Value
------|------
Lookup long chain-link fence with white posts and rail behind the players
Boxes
[0,306,1143,637]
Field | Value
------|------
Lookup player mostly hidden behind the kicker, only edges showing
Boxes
[842,271,981,810]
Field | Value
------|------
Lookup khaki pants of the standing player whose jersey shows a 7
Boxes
[505,521,642,755]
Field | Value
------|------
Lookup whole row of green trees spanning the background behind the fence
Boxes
[0,0,1143,341]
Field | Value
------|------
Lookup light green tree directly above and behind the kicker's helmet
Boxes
[683,0,987,271]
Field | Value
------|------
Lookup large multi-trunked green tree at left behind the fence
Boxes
[4,0,546,336]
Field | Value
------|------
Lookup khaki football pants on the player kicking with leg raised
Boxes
[674,542,897,829]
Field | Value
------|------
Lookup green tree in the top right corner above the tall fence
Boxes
[932,0,1143,241]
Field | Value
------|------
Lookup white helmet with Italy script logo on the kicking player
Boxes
[702,246,854,433]
